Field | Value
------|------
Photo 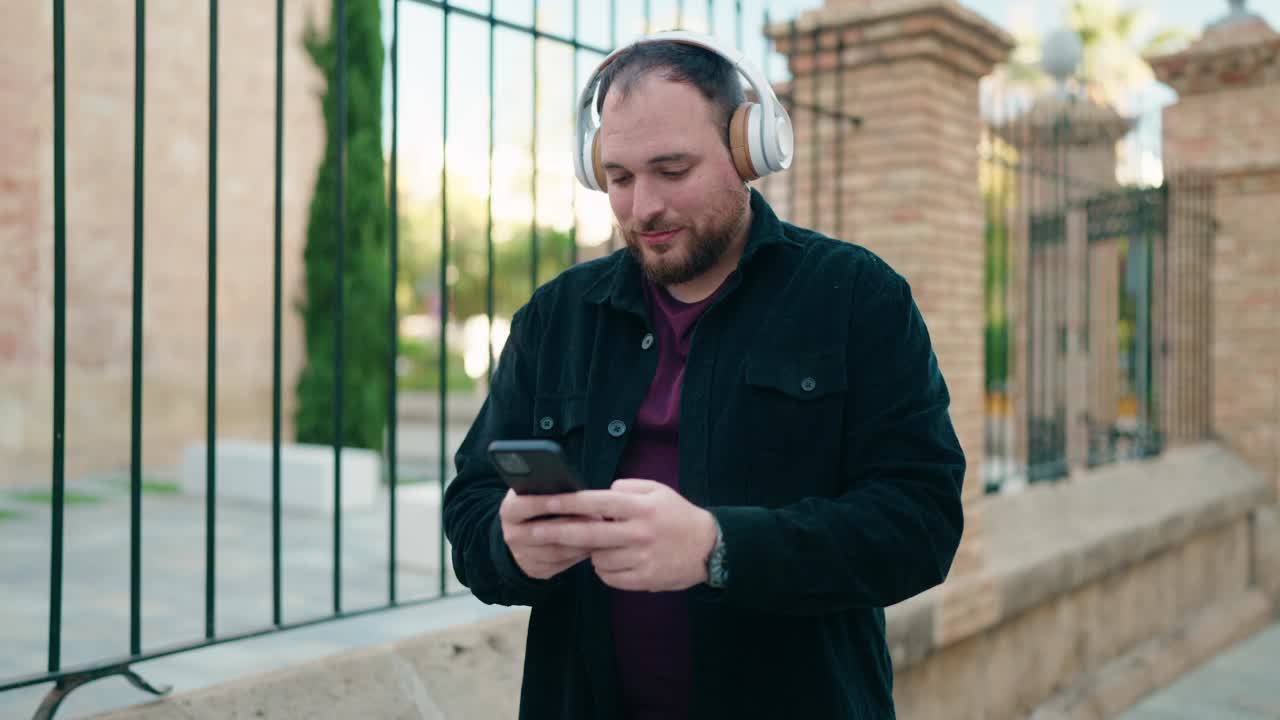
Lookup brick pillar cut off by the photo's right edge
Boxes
[1151,14,1280,489]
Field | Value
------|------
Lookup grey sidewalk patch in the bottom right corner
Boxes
[1119,623,1280,720]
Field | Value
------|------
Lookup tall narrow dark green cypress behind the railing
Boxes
[294,0,392,448]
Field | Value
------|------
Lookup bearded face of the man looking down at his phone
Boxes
[600,72,749,286]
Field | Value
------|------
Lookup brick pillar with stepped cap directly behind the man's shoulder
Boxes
[765,0,1014,604]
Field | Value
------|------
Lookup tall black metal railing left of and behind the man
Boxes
[0,0,860,719]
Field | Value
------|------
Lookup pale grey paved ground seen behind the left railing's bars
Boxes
[0,478,484,720]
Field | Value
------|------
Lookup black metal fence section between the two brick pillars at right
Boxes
[980,94,1215,492]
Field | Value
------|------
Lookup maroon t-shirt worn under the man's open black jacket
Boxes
[611,274,719,720]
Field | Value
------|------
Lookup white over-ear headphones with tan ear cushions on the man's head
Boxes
[573,31,795,192]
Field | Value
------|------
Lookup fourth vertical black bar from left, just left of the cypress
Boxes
[271,0,284,625]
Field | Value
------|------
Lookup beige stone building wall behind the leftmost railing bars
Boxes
[0,0,328,484]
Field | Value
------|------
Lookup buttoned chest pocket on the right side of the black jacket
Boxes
[741,347,849,506]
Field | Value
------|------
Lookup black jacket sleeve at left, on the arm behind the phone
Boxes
[443,297,564,605]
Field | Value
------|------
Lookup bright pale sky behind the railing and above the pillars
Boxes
[384,0,1280,243]
